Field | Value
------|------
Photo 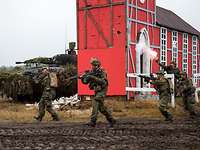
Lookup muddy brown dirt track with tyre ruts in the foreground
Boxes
[0,119,200,150]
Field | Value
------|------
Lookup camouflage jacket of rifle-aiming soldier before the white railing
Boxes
[151,78,171,95]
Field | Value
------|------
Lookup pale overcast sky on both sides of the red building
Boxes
[0,0,200,66]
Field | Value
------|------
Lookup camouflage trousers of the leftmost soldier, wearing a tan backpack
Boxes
[37,91,58,120]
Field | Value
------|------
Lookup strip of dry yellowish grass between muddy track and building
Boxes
[0,98,200,123]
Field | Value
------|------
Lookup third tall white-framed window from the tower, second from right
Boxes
[182,33,188,73]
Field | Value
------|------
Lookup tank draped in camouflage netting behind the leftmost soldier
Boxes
[0,54,77,102]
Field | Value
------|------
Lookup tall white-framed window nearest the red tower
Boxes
[160,27,167,65]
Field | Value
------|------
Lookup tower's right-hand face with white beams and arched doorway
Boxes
[126,0,156,99]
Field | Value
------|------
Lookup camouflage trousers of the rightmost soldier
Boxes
[183,94,195,115]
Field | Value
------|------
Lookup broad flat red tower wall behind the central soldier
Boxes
[77,0,126,95]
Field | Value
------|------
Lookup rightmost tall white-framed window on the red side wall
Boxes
[192,36,198,83]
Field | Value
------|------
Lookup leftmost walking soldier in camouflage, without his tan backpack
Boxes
[34,68,59,121]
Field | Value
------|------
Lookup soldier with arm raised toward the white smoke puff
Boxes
[156,59,180,95]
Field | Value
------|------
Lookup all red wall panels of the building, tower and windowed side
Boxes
[77,0,200,95]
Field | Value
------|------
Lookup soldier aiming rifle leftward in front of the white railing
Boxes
[150,71,173,122]
